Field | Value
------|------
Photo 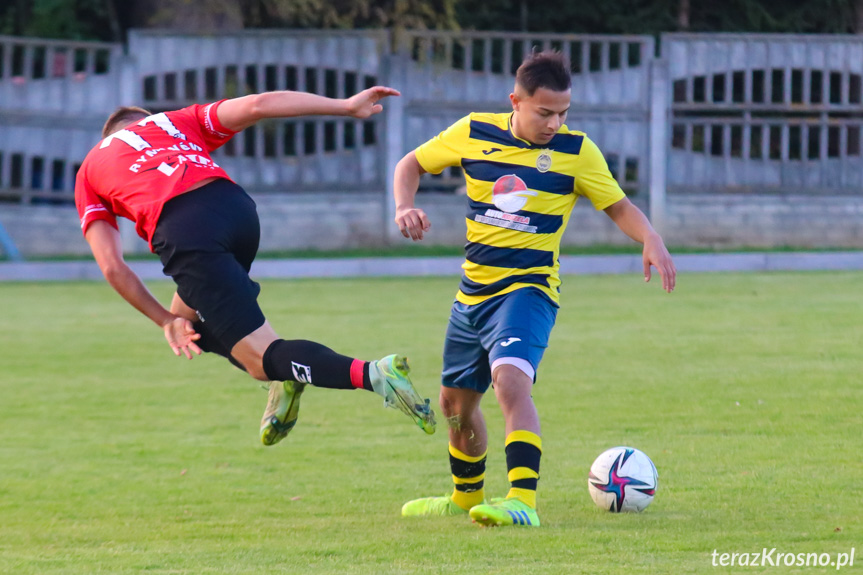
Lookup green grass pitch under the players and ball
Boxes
[0,273,863,575]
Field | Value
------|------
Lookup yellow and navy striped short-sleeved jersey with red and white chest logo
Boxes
[416,113,625,305]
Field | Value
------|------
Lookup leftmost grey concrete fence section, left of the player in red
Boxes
[0,36,122,206]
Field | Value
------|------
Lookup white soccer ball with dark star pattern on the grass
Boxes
[587,447,658,513]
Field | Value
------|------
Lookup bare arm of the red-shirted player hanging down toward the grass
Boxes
[85,220,201,359]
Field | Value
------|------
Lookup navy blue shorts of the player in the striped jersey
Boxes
[441,288,558,393]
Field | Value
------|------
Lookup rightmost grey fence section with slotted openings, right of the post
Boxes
[662,34,863,194]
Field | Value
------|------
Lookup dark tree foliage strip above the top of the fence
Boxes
[0,0,863,41]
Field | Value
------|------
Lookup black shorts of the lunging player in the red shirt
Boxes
[152,179,264,351]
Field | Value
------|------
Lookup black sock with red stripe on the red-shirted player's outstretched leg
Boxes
[263,339,372,391]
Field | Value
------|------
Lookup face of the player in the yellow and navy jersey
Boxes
[509,85,572,146]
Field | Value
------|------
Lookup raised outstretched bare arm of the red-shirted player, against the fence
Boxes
[217,86,399,132]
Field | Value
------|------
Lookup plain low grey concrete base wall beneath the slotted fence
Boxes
[0,193,863,258]
